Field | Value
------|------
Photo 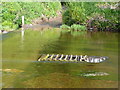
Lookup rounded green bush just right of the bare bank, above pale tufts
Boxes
[63,2,86,25]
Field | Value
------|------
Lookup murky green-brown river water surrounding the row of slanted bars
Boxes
[1,30,118,88]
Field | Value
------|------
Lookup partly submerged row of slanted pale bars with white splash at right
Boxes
[38,54,108,63]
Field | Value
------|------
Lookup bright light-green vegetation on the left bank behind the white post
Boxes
[0,2,61,30]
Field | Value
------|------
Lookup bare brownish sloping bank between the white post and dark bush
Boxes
[23,12,62,30]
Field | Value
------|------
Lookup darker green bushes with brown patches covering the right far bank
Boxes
[63,2,119,30]
